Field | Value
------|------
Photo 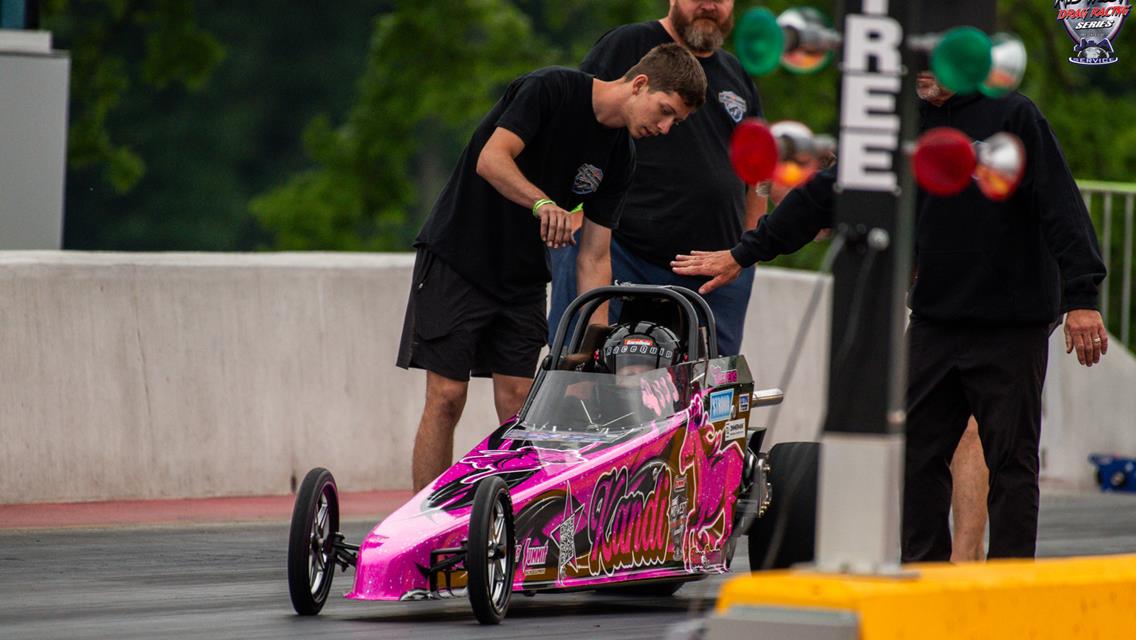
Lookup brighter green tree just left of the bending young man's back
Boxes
[252,0,549,250]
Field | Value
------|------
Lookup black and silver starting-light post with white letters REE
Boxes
[817,0,994,573]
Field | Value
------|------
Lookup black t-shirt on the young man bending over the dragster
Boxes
[415,67,635,302]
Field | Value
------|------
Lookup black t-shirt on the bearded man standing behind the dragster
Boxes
[580,22,761,268]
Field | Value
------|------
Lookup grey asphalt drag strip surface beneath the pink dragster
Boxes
[0,493,1136,640]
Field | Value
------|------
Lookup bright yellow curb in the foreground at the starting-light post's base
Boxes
[716,555,1136,640]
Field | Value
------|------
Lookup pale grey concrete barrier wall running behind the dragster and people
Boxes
[0,251,1136,504]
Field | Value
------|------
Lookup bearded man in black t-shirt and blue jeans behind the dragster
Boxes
[549,0,765,354]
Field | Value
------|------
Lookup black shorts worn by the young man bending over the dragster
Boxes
[396,248,549,381]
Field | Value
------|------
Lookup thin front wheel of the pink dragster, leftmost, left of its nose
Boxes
[287,468,340,615]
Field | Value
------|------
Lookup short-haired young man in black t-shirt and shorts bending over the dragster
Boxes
[398,45,705,491]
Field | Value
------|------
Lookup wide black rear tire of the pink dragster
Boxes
[747,442,820,571]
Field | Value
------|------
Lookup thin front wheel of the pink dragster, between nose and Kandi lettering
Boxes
[466,476,516,624]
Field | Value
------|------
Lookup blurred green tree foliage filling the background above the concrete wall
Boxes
[42,0,1136,327]
